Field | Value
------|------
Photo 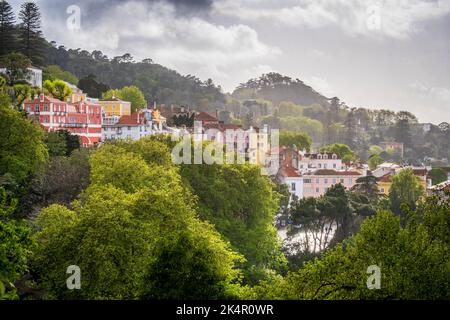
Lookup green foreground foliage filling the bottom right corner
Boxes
[276,194,450,300]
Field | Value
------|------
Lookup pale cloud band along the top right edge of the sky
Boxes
[213,0,450,39]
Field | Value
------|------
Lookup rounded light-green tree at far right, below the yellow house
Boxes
[389,169,425,215]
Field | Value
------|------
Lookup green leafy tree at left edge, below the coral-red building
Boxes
[0,102,47,188]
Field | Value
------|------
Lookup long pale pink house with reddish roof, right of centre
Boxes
[303,169,363,198]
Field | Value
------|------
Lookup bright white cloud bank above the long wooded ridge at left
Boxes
[31,0,280,90]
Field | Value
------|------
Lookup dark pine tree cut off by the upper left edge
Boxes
[0,0,15,56]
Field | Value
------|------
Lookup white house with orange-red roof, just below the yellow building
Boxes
[102,109,154,141]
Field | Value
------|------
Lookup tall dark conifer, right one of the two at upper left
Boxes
[19,2,44,65]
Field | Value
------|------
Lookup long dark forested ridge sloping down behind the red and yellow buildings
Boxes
[47,43,224,106]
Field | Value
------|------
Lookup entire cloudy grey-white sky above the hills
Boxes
[9,0,450,124]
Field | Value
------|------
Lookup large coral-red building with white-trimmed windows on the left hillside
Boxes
[24,94,103,146]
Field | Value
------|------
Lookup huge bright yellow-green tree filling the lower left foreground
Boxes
[31,144,242,299]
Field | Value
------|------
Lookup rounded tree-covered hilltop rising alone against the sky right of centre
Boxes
[233,72,329,106]
